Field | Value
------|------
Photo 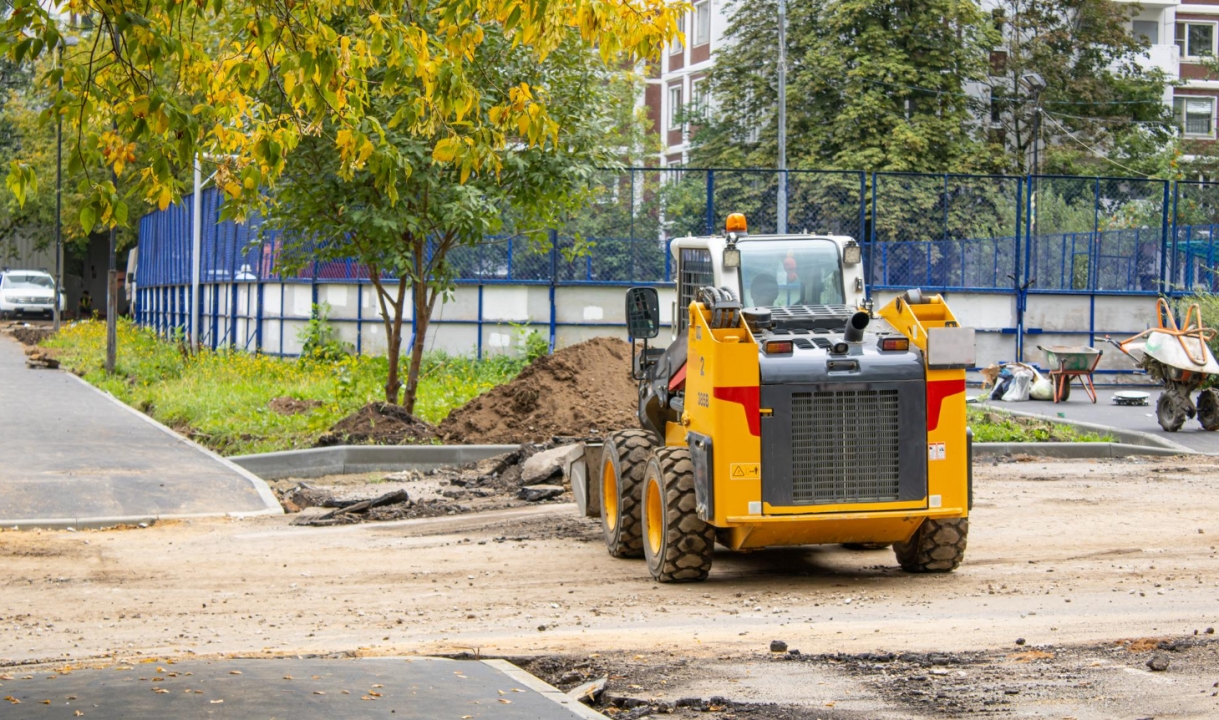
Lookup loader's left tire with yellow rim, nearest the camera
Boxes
[640,447,716,582]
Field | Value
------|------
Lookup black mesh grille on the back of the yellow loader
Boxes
[791,390,900,504]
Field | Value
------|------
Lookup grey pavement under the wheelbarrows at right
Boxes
[972,381,1219,454]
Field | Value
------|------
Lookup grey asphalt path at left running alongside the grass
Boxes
[0,337,282,528]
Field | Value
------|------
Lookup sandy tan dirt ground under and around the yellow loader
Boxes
[7,456,1219,719]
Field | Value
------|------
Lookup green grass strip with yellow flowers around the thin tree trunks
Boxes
[44,320,524,456]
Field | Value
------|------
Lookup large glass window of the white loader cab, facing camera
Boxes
[737,239,845,307]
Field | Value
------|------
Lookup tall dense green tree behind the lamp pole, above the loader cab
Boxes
[695,0,995,172]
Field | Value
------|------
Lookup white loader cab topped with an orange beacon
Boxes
[672,219,865,339]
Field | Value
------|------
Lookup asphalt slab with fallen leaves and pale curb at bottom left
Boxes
[0,658,601,720]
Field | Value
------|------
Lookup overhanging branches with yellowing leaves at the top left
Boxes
[0,0,685,233]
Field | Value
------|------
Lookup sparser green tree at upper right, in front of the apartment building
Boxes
[991,0,1175,177]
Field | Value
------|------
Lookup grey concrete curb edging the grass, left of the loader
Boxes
[228,445,519,480]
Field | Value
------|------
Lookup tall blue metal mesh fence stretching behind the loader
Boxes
[135,168,1219,360]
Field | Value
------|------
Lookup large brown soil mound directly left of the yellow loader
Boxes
[439,337,639,445]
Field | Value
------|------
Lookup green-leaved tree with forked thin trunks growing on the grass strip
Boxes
[269,28,643,411]
